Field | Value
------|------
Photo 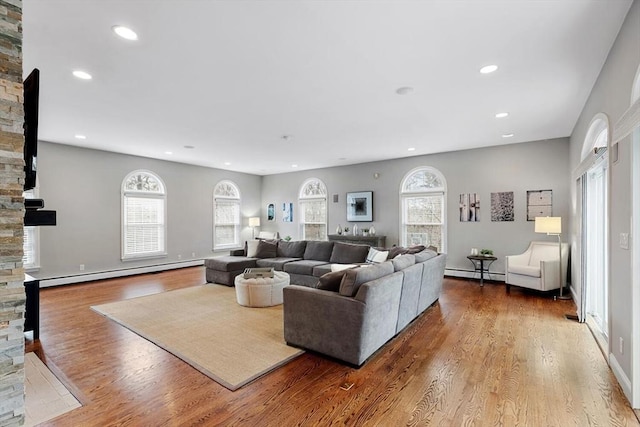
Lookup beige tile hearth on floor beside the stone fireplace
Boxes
[24,353,82,427]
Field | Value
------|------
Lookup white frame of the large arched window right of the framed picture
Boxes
[399,166,447,253]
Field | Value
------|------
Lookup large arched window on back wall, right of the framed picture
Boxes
[400,166,447,252]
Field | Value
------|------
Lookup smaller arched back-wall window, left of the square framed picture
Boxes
[298,178,327,240]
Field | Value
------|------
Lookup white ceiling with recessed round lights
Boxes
[23,0,632,175]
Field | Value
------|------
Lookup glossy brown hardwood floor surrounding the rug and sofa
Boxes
[27,267,639,426]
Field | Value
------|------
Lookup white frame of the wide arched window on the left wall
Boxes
[120,169,168,261]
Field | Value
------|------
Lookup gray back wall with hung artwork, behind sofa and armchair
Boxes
[262,138,570,278]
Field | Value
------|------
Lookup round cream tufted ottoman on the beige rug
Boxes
[234,271,289,307]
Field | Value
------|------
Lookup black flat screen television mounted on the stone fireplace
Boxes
[23,68,40,191]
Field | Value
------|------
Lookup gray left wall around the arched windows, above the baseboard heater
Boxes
[32,141,262,279]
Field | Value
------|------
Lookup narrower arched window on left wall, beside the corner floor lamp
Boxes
[213,181,240,250]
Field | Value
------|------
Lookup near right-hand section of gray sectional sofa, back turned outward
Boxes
[283,249,446,366]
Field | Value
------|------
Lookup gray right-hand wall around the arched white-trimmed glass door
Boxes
[570,1,640,402]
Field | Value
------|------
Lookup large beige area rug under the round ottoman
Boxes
[91,285,303,390]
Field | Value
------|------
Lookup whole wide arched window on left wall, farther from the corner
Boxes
[122,170,167,260]
